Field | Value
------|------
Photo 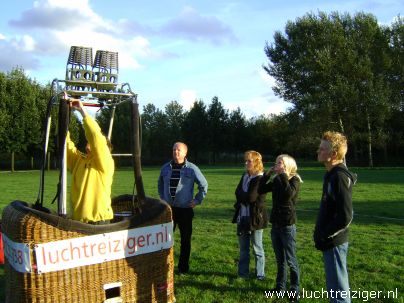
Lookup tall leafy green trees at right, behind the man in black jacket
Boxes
[264,12,404,166]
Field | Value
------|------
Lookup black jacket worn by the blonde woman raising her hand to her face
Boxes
[259,173,300,227]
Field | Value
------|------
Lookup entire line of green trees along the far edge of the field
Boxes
[0,12,404,170]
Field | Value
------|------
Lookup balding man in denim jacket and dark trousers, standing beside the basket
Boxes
[158,142,208,274]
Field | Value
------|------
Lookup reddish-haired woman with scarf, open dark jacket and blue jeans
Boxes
[233,151,268,280]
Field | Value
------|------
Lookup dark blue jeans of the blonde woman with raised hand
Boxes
[271,225,299,293]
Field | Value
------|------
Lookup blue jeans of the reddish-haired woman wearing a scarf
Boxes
[238,229,265,278]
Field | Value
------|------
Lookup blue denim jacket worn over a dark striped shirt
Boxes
[157,159,208,208]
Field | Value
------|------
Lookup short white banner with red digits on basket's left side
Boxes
[3,233,32,273]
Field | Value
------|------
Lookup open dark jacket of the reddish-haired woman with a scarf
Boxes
[232,174,268,230]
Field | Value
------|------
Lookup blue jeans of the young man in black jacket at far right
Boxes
[323,242,351,303]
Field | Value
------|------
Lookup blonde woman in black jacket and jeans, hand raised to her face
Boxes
[259,155,302,302]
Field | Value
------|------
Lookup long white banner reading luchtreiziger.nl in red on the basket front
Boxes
[35,222,173,273]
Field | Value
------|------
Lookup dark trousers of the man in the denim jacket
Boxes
[172,207,194,273]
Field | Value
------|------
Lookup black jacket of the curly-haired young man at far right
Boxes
[314,164,356,251]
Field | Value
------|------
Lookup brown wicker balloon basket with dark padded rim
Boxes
[2,195,175,303]
